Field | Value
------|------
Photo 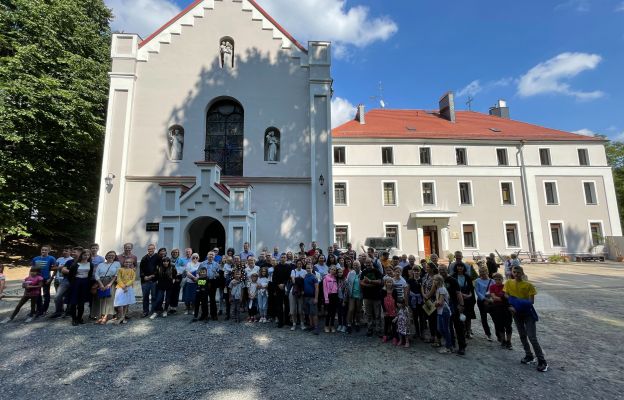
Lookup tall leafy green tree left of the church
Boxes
[0,0,112,240]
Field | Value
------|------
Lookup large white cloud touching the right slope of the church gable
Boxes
[261,0,399,57]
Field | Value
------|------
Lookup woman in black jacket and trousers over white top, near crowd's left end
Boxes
[62,249,95,326]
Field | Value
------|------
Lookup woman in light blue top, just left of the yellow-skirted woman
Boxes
[91,250,121,324]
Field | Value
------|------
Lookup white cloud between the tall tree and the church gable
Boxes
[104,0,180,39]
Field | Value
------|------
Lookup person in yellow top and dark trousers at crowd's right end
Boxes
[503,265,548,372]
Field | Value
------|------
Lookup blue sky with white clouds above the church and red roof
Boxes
[105,0,624,140]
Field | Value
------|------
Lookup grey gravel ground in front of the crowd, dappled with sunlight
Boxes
[0,264,624,400]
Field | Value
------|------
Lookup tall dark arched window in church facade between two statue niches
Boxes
[204,100,244,176]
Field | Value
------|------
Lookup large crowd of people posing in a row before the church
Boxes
[0,242,548,372]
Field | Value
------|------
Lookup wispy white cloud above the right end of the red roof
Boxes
[518,53,604,100]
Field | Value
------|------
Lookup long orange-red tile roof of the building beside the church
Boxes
[332,109,603,141]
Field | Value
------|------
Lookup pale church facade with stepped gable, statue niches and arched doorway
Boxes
[95,0,333,253]
